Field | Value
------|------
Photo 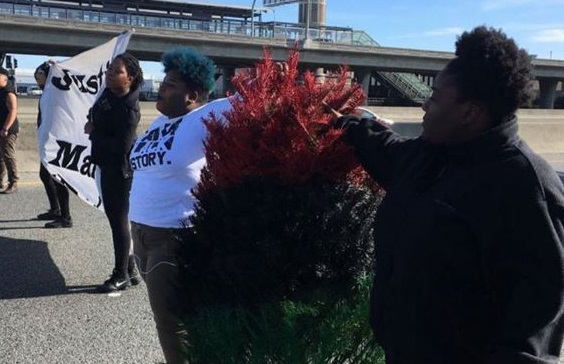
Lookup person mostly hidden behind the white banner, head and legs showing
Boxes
[33,62,72,228]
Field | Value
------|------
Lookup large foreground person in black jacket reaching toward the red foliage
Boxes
[337,26,564,364]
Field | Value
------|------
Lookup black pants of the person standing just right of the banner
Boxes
[100,166,131,273]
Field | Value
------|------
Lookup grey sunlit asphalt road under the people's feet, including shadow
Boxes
[0,173,164,364]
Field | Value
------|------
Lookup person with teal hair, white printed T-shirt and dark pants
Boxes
[129,48,231,364]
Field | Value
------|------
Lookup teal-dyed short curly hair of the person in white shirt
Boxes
[162,47,215,93]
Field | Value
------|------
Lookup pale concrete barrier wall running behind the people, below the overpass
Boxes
[13,98,564,171]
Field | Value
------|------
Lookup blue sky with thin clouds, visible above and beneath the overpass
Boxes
[7,0,564,78]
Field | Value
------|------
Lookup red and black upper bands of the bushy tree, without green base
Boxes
[182,52,380,308]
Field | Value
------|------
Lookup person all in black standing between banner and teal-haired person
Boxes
[84,53,143,292]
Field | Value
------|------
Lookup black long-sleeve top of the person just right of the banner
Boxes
[90,89,141,178]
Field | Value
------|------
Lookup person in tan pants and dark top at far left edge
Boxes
[0,67,20,194]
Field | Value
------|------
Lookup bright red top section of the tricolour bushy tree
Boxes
[199,51,365,193]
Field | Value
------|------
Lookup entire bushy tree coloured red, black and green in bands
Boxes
[180,52,383,364]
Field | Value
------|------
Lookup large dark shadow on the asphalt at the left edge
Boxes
[0,236,69,299]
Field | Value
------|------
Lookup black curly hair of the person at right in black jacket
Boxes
[445,26,532,122]
